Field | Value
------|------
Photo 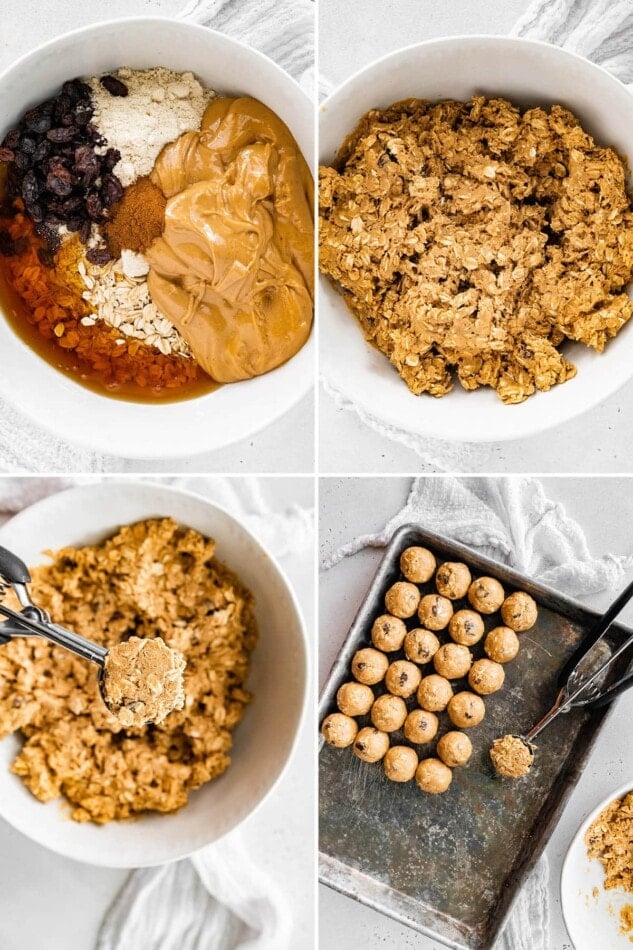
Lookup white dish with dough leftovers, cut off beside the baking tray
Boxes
[560,782,633,950]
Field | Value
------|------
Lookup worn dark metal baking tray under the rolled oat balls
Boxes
[319,525,630,950]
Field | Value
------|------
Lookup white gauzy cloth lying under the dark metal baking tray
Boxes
[322,477,633,950]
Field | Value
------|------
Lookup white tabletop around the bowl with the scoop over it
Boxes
[0,478,315,950]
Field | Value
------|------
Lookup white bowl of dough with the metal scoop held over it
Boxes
[0,482,307,867]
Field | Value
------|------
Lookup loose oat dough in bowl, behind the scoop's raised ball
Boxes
[0,518,257,824]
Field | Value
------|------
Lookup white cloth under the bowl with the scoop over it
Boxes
[0,477,314,950]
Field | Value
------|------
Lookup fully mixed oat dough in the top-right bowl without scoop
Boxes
[319,96,633,403]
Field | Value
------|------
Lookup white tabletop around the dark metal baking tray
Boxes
[319,477,633,950]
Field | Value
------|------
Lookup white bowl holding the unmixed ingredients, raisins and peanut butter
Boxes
[0,17,314,458]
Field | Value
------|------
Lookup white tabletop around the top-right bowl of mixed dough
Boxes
[319,0,633,473]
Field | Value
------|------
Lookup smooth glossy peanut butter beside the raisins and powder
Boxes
[147,98,313,383]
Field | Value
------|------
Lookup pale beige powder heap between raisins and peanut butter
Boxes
[88,66,215,186]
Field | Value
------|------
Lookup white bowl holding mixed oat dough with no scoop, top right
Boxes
[319,36,633,442]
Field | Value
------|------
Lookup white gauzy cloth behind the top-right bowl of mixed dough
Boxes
[319,0,633,472]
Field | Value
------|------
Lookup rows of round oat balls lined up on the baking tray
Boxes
[321,547,537,794]
